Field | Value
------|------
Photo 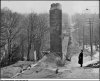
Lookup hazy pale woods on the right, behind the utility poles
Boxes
[72,13,99,48]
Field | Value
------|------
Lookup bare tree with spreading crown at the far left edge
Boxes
[1,9,20,63]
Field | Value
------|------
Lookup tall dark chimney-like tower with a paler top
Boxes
[50,3,62,56]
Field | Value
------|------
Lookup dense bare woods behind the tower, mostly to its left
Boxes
[0,8,69,66]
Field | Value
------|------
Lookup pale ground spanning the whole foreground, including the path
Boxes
[1,55,99,79]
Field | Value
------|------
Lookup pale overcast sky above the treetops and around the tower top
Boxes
[1,1,99,15]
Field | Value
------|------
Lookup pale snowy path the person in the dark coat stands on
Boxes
[57,55,99,79]
